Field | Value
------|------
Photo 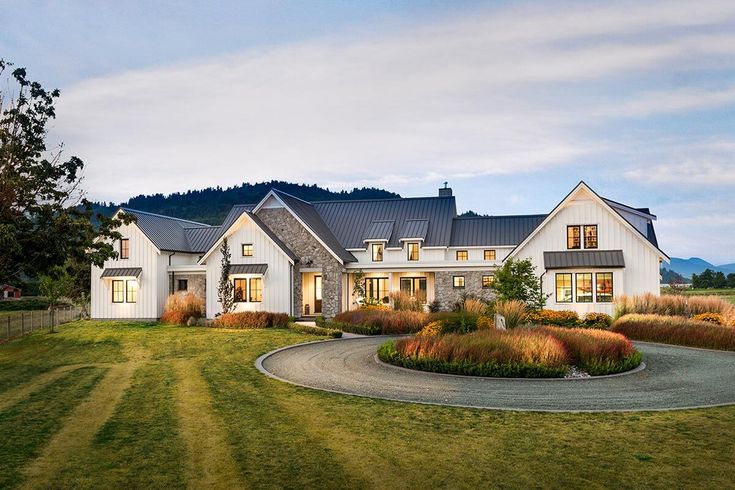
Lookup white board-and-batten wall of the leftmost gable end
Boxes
[90,223,162,319]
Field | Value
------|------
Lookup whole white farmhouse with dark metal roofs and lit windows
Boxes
[91,182,669,319]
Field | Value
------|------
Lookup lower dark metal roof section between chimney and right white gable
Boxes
[451,214,547,247]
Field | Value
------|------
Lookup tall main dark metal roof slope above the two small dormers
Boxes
[313,197,457,249]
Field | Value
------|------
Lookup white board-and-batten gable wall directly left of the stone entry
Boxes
[206,217,292,318]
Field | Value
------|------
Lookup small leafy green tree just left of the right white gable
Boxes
[491,258,550,309]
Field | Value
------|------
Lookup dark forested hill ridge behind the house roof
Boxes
[93,180,401,224]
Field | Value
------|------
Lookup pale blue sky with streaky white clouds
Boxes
[0,0,735,264]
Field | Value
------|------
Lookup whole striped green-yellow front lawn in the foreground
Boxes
[0,322,735,488]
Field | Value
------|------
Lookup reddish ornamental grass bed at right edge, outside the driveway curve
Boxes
[612,314,735,351]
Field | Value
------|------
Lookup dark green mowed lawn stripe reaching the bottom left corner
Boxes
[0,367,105,488]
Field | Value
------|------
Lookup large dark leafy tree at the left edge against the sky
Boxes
[0,60,134,290]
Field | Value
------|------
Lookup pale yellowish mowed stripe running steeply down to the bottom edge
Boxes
[174,359,242,488]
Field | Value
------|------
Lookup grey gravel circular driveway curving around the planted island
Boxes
[256,337,735,412]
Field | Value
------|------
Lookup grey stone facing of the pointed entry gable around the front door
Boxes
[258,208,344,318]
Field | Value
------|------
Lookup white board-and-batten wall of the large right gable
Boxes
[516,196,660,314]
